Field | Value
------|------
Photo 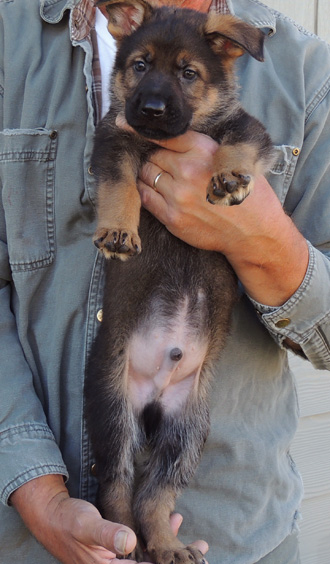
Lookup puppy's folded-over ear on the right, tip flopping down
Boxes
[204,14,265,61]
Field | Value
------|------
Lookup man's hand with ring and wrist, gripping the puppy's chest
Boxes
[117,116,309,306]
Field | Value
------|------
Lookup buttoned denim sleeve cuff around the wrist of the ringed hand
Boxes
[249,242,330,369]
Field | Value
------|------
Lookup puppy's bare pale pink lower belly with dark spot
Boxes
[128,303,207,412]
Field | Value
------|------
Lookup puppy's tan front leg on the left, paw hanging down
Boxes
[93,169,141,260]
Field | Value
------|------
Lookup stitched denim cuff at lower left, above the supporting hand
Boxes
[0,423,68,504]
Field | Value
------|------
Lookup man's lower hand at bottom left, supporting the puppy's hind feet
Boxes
[10,475,208,564]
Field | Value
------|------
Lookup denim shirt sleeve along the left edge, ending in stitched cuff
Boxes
[0,82,67,503]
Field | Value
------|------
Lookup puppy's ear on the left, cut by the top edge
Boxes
[95,0,153,41]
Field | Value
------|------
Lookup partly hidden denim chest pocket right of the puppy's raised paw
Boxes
[266,145,300,206]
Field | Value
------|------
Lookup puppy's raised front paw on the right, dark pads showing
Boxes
[207,171,252,206]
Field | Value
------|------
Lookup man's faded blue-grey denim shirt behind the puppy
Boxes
[0,0,330,564]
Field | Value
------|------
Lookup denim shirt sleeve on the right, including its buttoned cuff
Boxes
[250,79,330,369]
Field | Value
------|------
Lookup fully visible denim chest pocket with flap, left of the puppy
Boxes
[0,128,57,272]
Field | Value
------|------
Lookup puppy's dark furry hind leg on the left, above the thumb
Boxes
[85,349,142,530]
